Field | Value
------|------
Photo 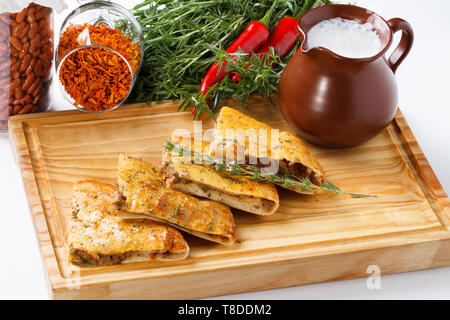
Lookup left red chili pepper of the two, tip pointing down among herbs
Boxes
[192,0,278,114]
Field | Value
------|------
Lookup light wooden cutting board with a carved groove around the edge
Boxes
[10,98,450,299]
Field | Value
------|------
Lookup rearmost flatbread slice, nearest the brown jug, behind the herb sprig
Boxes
[210,107,325,194]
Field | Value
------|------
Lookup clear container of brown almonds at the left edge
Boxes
[0,0,58,131]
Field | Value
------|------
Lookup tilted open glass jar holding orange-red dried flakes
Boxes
[56,1,143,112]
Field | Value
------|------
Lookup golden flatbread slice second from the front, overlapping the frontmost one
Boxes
[116,155,236,245]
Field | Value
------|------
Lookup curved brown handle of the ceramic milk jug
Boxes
[388,18,414,73]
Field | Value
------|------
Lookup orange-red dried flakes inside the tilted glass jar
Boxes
[58,24,141,111]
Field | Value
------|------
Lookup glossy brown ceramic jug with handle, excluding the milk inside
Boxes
[278,5,414,148]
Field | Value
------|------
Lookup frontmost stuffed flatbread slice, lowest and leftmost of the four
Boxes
[68,181,189,266]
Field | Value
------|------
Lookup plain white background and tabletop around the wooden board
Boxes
[0,0,450,299]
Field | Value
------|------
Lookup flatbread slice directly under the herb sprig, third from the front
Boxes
[163,137,280,215]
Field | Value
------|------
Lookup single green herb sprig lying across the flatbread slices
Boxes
[164,141,376,199]
